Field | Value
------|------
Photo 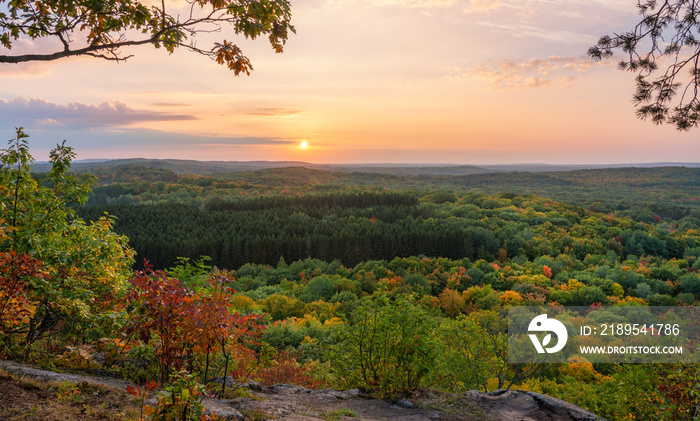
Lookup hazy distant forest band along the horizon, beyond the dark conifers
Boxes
[79,165,700,226]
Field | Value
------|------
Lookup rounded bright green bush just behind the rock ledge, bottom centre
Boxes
[329,294,436,396]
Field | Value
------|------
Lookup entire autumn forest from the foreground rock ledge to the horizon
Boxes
[5,146,700,420]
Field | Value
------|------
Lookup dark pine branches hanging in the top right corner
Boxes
[588,0,700,131]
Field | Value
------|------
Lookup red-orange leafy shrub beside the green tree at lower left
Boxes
[122,267,263,382]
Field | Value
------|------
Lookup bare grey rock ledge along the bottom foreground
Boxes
[0,361,602,421]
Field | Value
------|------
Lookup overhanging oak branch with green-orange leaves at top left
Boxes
[0,0,294,75]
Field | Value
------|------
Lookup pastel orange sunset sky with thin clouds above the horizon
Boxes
[0,0,700,165]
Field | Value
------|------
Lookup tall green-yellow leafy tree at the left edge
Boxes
[0,128,132,353]
